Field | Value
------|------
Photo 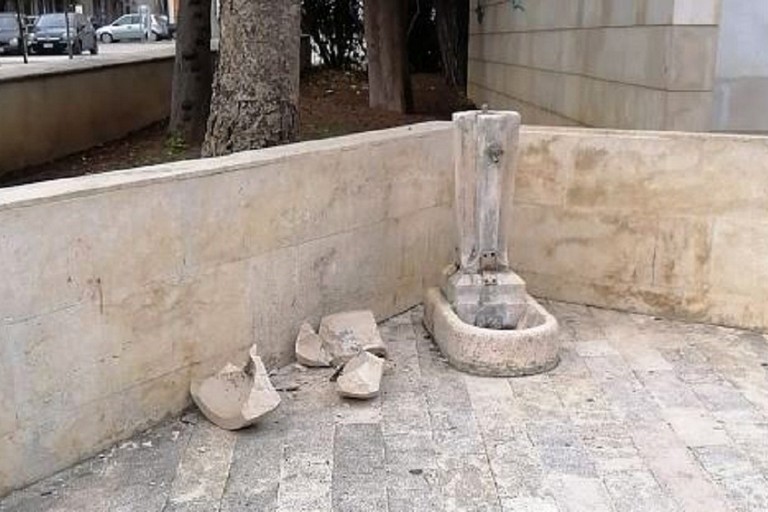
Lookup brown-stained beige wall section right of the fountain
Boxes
[510,128,768,330]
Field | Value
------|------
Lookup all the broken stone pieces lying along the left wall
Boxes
[190,311,387,430]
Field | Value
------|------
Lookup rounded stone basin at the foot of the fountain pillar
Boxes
[424,288,560,377]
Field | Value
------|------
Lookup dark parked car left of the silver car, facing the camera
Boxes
[29,12,99,55]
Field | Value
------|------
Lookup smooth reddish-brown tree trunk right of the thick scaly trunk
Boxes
[363,0,413,113]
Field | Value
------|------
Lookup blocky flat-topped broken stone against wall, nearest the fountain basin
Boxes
[318,310,387,366]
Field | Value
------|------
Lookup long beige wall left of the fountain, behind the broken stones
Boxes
[0,123,453,494]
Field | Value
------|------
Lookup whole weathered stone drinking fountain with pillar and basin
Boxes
[424,110,559,377]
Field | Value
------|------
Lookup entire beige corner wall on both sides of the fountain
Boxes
[0,123,768,494]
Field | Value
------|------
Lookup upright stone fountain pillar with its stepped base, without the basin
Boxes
[443,111,526,329]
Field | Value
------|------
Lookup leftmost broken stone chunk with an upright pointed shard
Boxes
[190,346,280,430]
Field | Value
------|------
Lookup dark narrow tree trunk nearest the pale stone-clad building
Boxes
[435,0,469,91]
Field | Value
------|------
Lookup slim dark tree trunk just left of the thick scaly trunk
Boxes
[168,0,213,144]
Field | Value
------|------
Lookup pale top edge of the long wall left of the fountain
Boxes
[0,121,451,211]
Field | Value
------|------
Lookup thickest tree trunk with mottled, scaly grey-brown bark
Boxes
[203,0,301,156]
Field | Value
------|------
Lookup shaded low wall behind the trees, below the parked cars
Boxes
[0,54,173,175]
